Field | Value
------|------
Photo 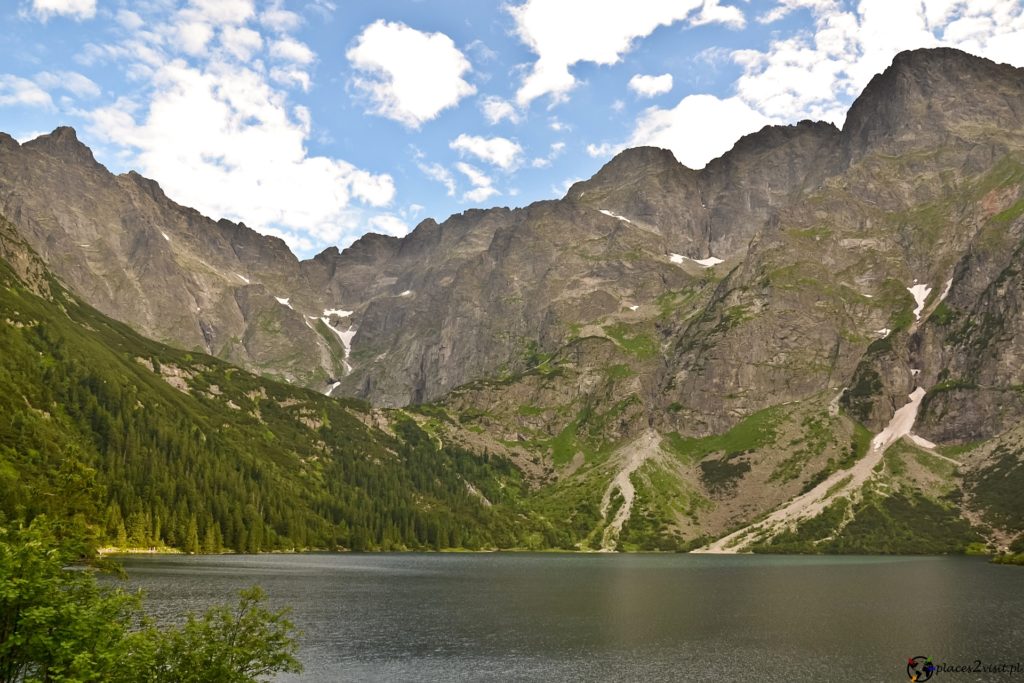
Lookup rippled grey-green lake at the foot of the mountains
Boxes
[117,553,1024,682]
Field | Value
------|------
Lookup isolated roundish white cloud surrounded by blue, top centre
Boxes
[345,20,476,128]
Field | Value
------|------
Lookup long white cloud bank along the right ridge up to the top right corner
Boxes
[614,0,1024,168]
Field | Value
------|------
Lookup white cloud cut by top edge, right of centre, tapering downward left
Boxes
[509,0,742,106]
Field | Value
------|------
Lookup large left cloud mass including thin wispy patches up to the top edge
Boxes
[74,0,397,251]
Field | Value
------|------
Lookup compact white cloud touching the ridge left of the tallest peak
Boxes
[626,95,771,169]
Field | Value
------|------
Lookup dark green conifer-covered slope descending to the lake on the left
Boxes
[0,248,520,552]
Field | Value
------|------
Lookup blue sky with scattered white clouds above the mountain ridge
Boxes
[0,0,1024,258]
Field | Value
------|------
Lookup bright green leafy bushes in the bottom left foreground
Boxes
[0,517,302,683]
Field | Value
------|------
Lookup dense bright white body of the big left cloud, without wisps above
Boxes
[84,60,395,248]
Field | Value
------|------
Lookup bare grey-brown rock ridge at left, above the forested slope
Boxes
[0,128,343,386]
